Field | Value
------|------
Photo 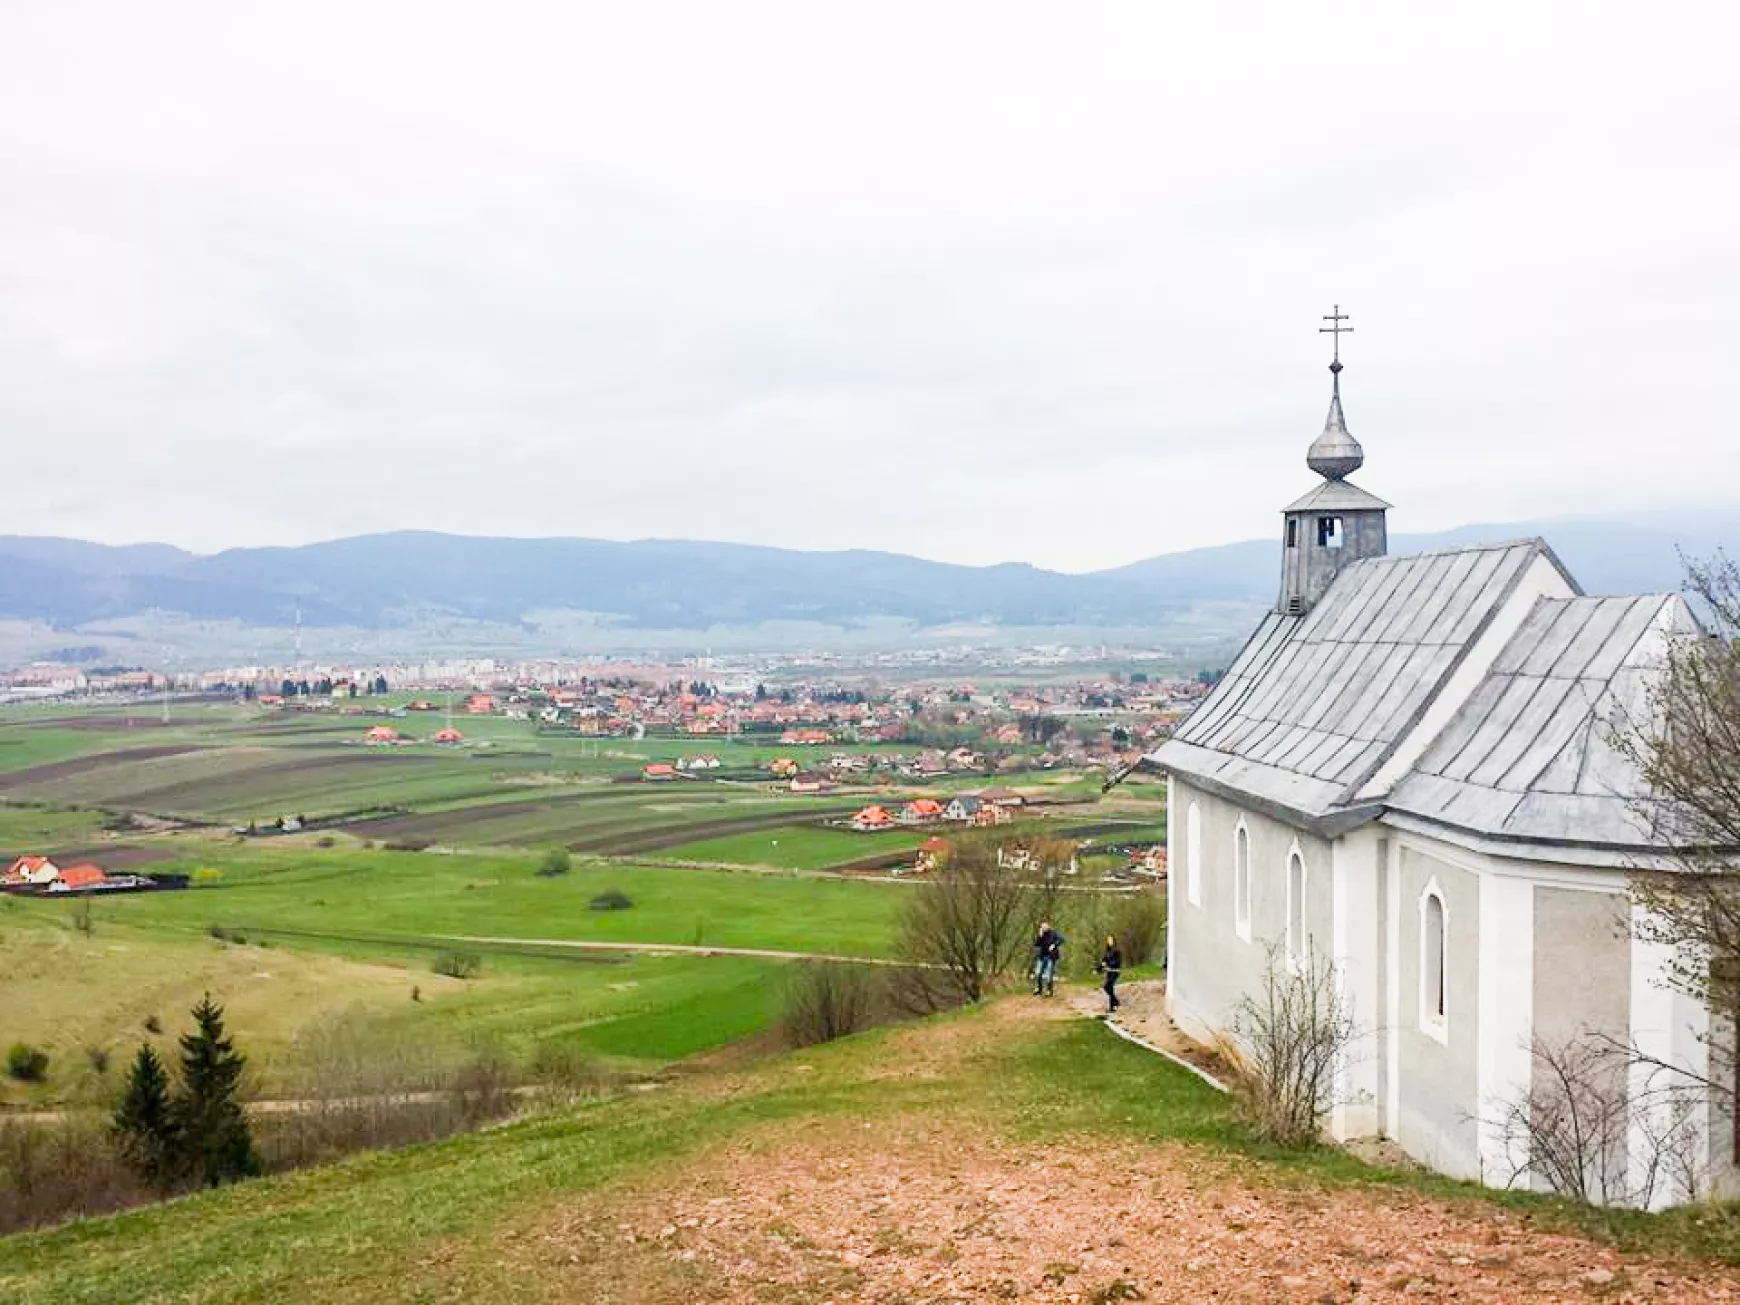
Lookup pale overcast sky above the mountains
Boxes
[0,0,1740,571]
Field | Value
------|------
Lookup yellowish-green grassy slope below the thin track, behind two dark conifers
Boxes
[0,912,785,1107]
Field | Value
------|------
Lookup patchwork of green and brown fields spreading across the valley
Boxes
[0,699,1162,1120]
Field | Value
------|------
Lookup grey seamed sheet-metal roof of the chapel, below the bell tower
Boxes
[1152,539,1698,849]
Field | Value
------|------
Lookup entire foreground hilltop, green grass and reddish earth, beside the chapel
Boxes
[0,999,1740,1305]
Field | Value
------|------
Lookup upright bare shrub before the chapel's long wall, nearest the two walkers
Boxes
[1220,943,1355,1147]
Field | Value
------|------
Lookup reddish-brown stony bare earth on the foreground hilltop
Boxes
[508,1117,1740,1305]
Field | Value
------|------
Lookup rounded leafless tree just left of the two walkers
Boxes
[896,835,1041,1009]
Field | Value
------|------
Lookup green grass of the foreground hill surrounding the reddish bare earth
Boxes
[0,1004,1740,1305]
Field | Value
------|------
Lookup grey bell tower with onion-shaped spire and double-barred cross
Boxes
[1275,305,1390,616]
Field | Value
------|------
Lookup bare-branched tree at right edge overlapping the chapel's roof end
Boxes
[1610,553,1740,1101]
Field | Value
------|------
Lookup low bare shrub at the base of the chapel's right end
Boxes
[1491,1034,1709,1208]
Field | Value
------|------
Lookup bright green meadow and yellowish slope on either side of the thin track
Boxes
[0,840,903,1103]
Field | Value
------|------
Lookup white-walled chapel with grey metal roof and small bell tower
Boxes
[1148,310,1737,1208]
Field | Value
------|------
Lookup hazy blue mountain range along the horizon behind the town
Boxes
[0,512,1740,664]
